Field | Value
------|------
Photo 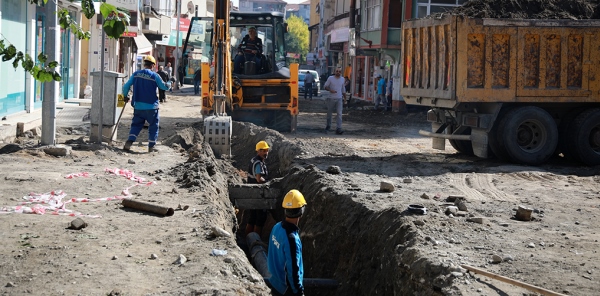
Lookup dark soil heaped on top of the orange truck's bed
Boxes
[437,0,600,20]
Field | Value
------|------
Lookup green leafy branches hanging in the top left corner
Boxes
[0,0,129,82]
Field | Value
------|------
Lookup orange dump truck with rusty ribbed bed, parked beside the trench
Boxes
[400,16,600,165]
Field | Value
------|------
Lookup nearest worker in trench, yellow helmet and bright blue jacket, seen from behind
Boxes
[267,189,306,295]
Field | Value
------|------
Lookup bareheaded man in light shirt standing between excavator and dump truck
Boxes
[323,67,346,135]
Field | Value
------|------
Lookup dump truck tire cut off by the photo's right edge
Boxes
[569,108,600,166]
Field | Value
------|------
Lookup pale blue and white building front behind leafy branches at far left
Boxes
[0,0,82,117]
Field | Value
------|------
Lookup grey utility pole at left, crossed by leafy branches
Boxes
[41,2,62,145]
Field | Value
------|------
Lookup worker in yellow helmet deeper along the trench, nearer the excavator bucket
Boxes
[246,141,270,236]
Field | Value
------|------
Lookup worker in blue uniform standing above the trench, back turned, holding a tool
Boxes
[123,55,171,152]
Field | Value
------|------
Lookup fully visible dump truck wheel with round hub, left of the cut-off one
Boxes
[499,106,558,165]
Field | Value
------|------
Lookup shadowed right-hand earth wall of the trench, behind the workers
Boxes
[217,122,460,295]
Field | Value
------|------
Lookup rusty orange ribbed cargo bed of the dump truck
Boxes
[401,16,600,108]
